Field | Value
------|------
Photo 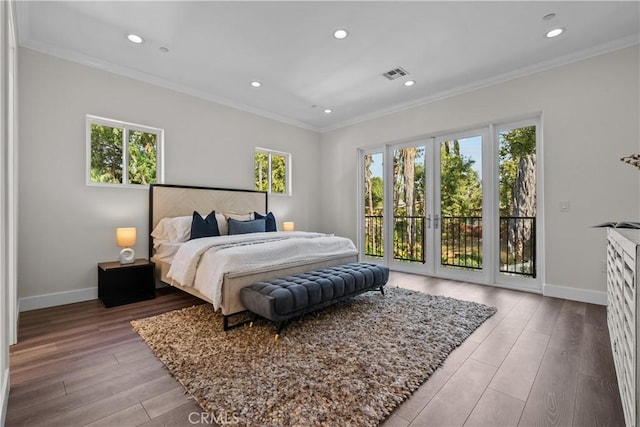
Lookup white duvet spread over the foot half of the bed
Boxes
[167,231,358,310]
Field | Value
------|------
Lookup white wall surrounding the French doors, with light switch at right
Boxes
[322,46,640,296]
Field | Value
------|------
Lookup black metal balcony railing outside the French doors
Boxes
[365,215,536,277]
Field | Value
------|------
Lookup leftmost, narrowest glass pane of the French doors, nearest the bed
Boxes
[363,153,384,258]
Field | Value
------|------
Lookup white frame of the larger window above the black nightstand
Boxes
[85,114,164,189]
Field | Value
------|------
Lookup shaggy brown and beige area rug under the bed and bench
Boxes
[131,288,496,426]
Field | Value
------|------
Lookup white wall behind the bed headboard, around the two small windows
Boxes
[18,49,320,310]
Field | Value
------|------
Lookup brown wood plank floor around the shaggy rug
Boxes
[7,273,624,427]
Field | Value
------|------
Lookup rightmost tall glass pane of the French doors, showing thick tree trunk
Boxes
[499,126,537,277]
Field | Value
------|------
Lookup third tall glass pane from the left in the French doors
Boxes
[440,136,482,270]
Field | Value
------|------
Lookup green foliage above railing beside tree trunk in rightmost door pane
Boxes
[499,126,536,216]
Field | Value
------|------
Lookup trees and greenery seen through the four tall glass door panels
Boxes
[364,126,536,275]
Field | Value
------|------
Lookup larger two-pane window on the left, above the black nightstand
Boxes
[87,115,164,186]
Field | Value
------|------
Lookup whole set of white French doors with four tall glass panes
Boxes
[359,118,541,289]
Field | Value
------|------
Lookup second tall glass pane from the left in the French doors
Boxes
[393,146,425,263]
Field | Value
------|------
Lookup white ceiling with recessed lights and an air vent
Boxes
[17,1,640,131]
